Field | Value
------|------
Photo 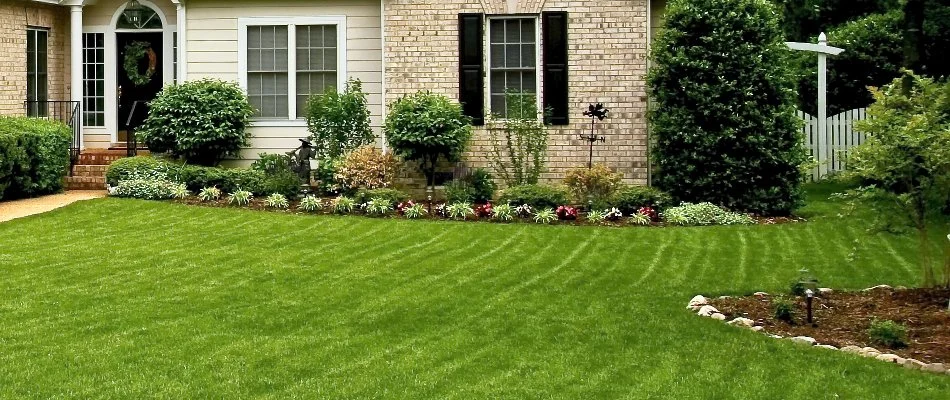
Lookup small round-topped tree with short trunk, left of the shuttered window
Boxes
[385,92,472,188]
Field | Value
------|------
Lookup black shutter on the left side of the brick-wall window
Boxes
[459,14,485,125]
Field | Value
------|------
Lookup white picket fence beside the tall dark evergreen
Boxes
[798,108,867,180]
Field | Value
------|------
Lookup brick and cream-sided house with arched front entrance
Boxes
[0,0,664,188]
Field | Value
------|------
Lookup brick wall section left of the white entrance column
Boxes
[0,0,69,115]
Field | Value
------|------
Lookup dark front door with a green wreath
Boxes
[116,32,164,145]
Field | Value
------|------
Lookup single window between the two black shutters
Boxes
[488,18,538,117]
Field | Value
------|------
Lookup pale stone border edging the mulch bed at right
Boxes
[686,285,950,375]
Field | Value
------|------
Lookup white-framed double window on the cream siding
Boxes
[240,17,345,120]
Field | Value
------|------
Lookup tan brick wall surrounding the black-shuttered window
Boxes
[384,0,647,188]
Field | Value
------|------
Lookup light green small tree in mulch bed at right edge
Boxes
[848,72,950,286]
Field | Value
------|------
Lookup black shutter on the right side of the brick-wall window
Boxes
[541,11,570,125]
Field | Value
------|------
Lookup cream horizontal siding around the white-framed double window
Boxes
[187,0,383,163]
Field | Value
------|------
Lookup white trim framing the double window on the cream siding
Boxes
[238,15,347,127]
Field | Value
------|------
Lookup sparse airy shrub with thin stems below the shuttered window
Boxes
[488,91,548,186]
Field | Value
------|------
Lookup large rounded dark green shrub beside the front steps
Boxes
[136,79,254,166]
